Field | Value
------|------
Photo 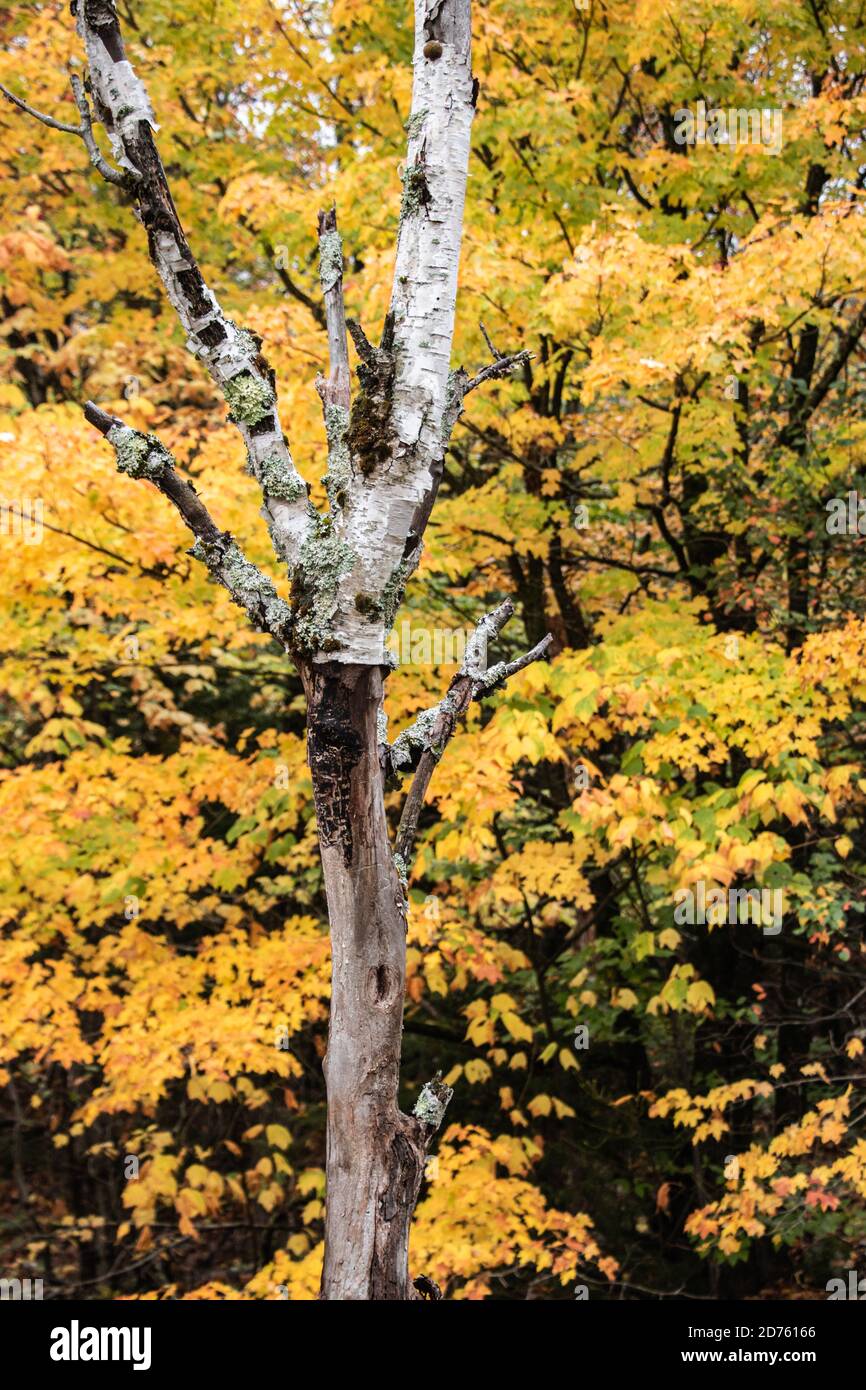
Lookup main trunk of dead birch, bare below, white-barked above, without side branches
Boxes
[306,0,473,1300]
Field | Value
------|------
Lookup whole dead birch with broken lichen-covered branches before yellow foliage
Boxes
[6,0,550,1300]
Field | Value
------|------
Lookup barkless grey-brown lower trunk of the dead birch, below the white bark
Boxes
[306,662,430,1300]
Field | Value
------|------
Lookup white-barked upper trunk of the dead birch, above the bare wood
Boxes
[317,0,474,664]
